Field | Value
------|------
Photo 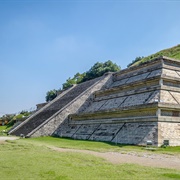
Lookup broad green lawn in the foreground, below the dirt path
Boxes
[0,139,180,180]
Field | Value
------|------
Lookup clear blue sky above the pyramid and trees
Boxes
[0,0,180,116]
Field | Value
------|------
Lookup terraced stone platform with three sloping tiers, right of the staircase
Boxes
[54,57,180,146]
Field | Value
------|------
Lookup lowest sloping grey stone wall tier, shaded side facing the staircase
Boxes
[54,119,158,146]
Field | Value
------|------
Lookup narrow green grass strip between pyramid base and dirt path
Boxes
[23,137,180,154]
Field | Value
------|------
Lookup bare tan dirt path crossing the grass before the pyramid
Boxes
[49,146,180,170]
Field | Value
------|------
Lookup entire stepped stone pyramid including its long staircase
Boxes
[9,56,180,146]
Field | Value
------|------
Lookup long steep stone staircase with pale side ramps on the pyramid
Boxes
[9,74,111,137]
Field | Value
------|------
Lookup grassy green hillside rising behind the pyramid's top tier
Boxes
[130,44,180,67]
